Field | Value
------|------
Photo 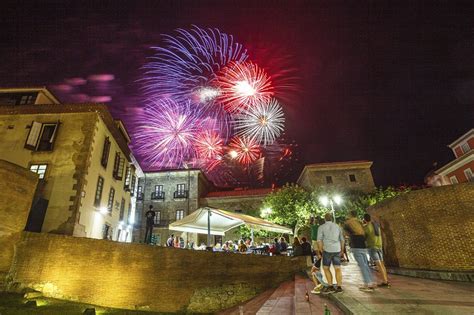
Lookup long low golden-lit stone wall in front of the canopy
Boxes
[9,232,306,313]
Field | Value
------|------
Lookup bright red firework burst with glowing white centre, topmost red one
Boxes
[215,62,274,113]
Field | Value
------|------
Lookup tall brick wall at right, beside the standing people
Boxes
[368,183,474,271]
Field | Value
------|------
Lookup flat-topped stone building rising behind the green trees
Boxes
[296,161,375,192]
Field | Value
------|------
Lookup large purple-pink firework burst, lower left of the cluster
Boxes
[136,99,203,168]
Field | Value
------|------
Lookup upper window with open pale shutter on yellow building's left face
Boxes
[25,121,59,151]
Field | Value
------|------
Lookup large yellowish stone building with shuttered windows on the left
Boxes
[0,88,139,241]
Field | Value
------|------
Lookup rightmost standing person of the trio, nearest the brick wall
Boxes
[364,213,390,287]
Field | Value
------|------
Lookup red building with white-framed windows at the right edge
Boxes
[434,129,474,186]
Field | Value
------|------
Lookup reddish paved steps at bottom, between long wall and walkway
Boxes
[219,275,343,315]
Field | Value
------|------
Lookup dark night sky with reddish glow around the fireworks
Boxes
[0,1,474,185]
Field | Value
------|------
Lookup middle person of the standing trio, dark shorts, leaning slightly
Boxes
[344,210,374,292]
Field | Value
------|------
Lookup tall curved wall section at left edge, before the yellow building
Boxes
[0,160,38,280]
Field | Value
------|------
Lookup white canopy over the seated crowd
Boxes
[169,207,293,235]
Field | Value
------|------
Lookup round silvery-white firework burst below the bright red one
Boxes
[235,99,285,146]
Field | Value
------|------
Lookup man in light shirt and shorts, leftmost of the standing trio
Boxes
[318,212,344,294]
